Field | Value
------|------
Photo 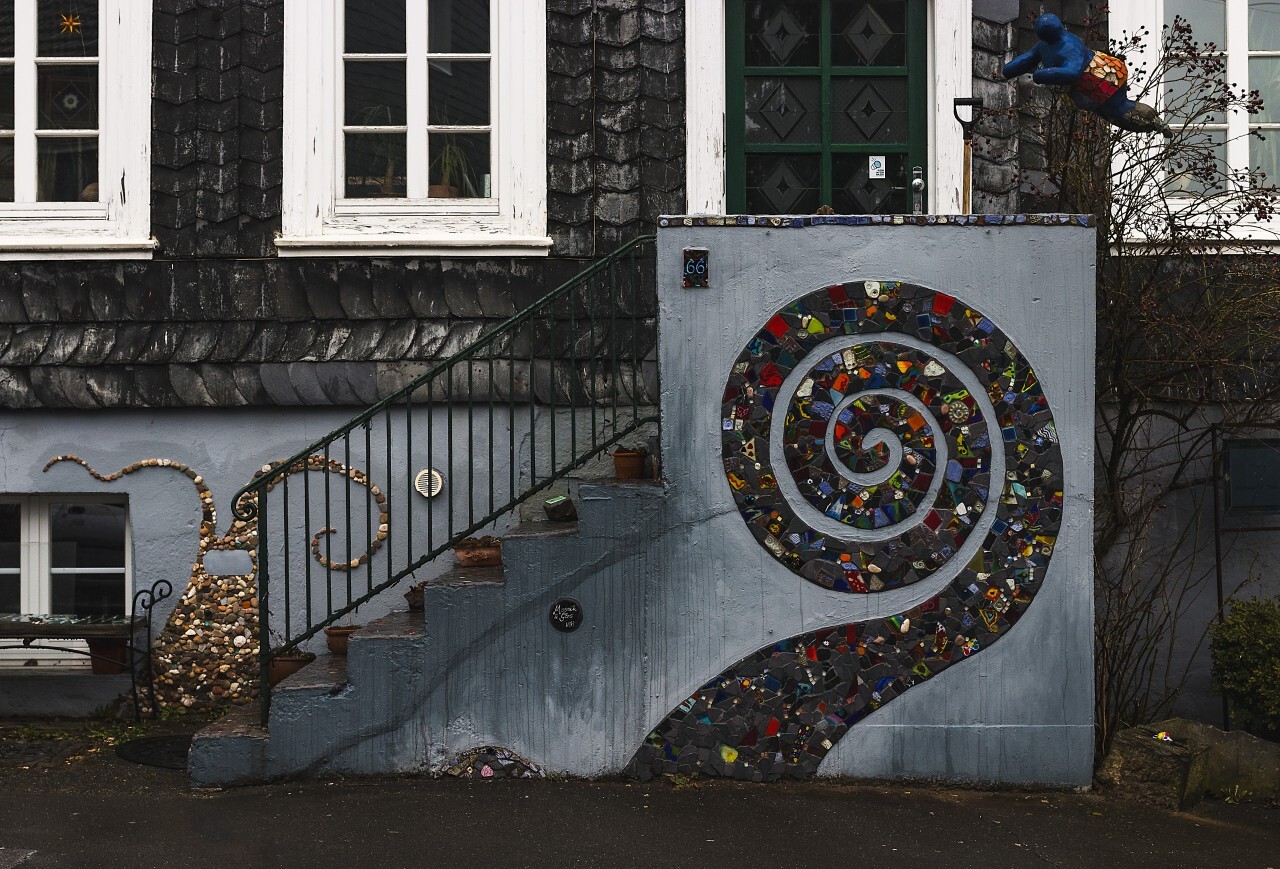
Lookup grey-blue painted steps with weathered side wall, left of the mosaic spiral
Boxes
[188,480,663,787]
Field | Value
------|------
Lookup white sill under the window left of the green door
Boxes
[275,234,552,257]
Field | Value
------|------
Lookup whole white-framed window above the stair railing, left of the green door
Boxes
[276,0,550,256]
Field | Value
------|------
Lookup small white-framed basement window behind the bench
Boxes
[0,494,133,667]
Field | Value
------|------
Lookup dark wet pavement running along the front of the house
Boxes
[0,722,1280,869]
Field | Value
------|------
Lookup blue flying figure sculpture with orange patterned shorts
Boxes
[1004,13,1174,136]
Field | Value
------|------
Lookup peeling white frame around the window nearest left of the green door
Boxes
[275,0,552,256]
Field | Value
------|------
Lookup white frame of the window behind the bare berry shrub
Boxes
[1107,0,1280,244]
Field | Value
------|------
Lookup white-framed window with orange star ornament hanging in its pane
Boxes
[0,0,154,260]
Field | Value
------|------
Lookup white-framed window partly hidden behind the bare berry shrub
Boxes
[1108,0,1280,241]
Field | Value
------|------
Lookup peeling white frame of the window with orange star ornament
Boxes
[0,0,155,260]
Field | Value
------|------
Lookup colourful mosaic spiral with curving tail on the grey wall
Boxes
[631,280,1062,781]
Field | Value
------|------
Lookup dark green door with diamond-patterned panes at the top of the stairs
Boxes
[724,0,929,214]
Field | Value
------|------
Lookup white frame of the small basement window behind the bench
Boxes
[0,493,133,669]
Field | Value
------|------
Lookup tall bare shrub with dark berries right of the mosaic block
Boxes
[993,8,1280,758]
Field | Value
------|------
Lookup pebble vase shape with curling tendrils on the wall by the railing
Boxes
[44,456,388,709]
